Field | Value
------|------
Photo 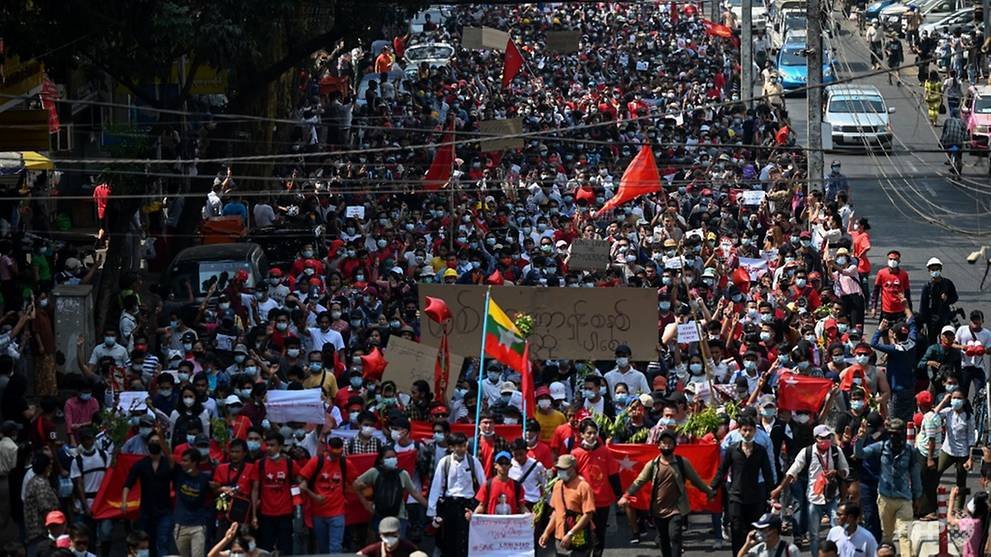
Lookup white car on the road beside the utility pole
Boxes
[822,85,895,147]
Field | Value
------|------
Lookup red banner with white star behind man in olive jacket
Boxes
[609,444,723,513]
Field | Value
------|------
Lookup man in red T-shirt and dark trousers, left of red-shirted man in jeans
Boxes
[251,431,297,555]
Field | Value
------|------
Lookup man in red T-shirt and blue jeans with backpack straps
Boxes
[299,437,348,553]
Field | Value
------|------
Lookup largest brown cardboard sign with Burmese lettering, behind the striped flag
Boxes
[419,284,658,361]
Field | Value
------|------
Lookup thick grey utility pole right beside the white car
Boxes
[805,0,823,191]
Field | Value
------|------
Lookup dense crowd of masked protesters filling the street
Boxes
[0,2,991,557]
